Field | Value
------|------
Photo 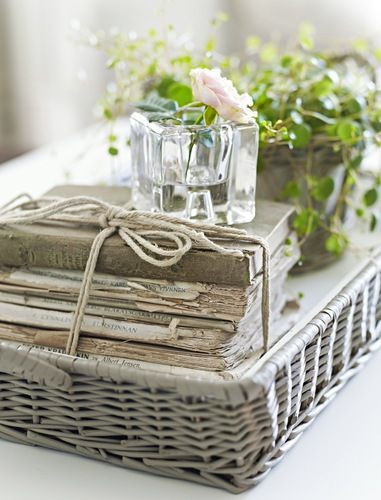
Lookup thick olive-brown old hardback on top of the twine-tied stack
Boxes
[0,186,293,286]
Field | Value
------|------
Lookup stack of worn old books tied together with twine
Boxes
[0,186,299,371]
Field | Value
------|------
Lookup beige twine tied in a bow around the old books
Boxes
[0,195,270,356]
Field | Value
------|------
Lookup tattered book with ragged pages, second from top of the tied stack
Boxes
[0,233,299,322]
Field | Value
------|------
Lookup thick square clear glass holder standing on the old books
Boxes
[131,112,259,224]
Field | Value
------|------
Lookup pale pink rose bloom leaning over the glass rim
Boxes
[190,68,256,123]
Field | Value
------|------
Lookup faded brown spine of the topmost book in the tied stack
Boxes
[0,227,253,286]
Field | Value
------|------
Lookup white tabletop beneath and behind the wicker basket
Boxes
[0,131,381,500]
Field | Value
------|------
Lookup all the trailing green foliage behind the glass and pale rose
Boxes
[85,18,381,255]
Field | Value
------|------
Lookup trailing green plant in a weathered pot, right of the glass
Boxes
[244,28,381,271]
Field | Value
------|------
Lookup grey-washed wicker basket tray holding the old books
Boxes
[0,252,381,493]
